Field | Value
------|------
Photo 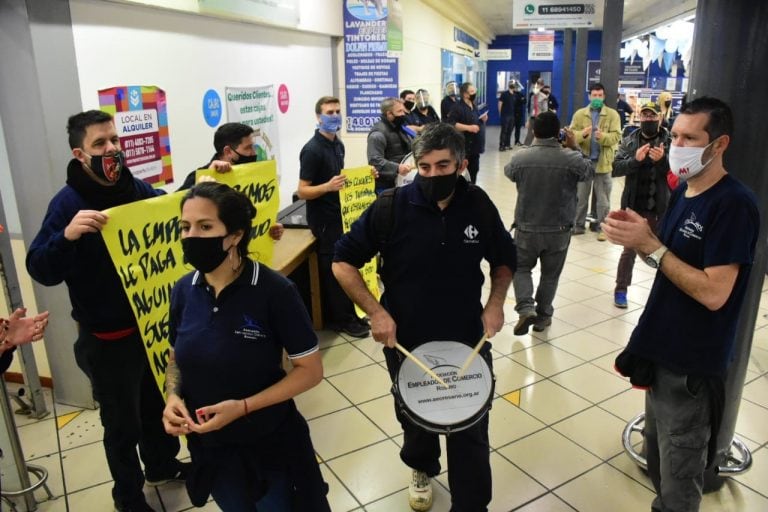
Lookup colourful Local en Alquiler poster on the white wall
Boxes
[99,85,173,185]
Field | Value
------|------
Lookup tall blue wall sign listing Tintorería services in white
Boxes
[344,0,398,133]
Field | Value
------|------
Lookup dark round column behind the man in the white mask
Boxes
[688,0,768,489]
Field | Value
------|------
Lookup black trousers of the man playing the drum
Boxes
[384,348,493,512]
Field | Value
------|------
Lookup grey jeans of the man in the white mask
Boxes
[643,365,711,512]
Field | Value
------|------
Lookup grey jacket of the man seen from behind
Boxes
[504,139,594,233]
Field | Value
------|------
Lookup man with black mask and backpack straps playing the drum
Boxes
[333,123,516,512]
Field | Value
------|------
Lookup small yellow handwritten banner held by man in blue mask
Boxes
[339,166,381,317]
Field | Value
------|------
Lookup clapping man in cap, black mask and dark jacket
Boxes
[612,101,670,308]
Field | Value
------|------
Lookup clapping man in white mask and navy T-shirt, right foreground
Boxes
[603,97,760,512]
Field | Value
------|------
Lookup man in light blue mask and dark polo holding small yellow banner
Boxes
[298,96,370,338]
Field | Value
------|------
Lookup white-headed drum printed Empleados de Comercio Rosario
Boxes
[392,341,495,434]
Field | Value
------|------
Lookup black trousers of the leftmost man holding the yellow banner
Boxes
[75,332,179,505]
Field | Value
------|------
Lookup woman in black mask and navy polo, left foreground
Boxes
[163,183,330,512]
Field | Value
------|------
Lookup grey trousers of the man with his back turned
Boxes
[512,229,571,318]
